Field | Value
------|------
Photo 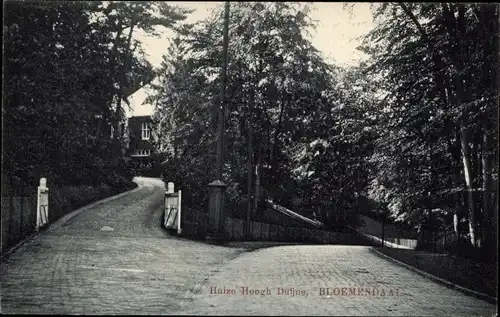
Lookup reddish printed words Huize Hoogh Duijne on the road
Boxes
[210,286,308,297]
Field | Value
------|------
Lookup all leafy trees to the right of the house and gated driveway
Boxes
[152,3,499,260]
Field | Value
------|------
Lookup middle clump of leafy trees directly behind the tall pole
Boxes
[152,3,371,230]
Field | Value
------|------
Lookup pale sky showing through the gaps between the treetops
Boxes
[127,1,374,116]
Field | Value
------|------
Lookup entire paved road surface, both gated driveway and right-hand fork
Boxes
[1,178,496,316]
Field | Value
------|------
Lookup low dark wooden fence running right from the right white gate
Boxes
[181,207,374,245]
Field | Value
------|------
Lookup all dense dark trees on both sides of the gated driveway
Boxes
[2,1,500,257]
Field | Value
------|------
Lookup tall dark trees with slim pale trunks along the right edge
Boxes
[364,3,500,255]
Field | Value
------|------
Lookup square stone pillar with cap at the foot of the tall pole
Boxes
[207,180,227,241]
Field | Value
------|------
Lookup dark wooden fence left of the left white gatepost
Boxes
[1,197,37,255]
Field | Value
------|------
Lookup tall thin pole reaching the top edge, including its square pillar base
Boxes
[207,1,229,241]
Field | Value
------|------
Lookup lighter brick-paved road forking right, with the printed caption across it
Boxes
[186,245,497,316]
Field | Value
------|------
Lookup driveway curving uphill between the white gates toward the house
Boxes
[1,178,246,314]
